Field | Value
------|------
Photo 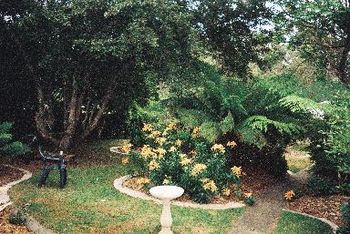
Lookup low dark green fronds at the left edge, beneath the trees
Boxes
[0,122,29,155]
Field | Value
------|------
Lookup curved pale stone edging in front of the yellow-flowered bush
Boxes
[113,175,245,210]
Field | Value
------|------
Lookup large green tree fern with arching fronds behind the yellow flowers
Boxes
[169,64,328,175]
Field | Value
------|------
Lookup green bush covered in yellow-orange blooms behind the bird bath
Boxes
[124,122,242,203]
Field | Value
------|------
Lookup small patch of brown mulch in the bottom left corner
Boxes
[0,206,32,234]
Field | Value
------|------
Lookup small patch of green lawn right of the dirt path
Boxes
[274,212,332,234]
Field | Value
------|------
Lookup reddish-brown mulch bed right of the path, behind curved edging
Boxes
[289,195,349,225]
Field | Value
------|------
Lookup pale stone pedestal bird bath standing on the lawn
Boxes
[150,185,184,234]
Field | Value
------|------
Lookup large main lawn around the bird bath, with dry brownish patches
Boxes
[11,165,243,233]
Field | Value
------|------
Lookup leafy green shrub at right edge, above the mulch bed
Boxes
[310,95,350,193]
